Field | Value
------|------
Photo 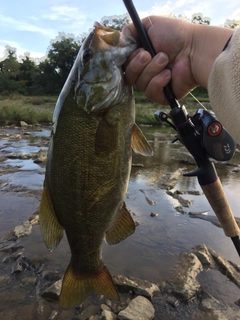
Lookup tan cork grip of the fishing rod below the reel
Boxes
[201,178,240,237]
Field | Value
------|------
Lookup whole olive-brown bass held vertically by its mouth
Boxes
[39,22,153,309]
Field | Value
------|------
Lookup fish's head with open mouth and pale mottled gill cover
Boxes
[73,22,137,114]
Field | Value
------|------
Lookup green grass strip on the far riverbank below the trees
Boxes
[0,91,208,126]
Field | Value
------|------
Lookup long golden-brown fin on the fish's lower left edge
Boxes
[39,180,64,250]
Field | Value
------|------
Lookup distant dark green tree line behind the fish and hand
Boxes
[0,13,238,95]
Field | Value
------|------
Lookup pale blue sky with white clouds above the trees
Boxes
[0,0,240,60]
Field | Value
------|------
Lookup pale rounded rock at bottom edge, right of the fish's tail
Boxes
[118,296,155,320]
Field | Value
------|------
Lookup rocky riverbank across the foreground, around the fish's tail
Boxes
[0,212,240,320]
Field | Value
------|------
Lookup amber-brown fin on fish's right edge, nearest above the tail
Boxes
[105,203,135,245]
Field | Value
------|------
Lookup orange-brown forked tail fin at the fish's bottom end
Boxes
[59,262,119,309]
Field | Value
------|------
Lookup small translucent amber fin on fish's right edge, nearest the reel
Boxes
[131,123,153,156]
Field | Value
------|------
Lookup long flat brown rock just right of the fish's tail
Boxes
[113,275,159,299]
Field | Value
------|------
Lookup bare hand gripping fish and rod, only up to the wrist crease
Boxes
[123,16,197,104]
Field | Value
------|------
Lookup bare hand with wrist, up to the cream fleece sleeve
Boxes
[123,16,233,104]
